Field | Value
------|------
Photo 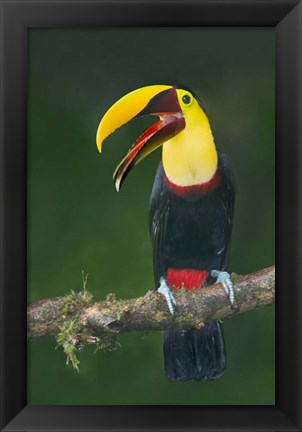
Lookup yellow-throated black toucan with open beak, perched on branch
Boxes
[96,85,235,381]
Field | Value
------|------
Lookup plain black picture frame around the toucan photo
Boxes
[0,0,302,431]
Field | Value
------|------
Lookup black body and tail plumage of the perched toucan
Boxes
[150,151,234,381]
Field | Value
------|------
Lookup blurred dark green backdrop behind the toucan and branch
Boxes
[28,28,275,405]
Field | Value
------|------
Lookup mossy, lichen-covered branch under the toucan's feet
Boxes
[27,266,275,369]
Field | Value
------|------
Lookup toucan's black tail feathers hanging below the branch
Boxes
[163,321,226,381]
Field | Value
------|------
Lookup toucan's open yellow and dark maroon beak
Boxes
[96,85,185,190]
